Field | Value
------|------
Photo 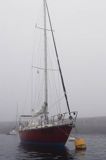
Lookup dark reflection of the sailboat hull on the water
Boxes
[19,144,74,160]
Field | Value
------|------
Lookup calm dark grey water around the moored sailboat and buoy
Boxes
[0,135,106,160]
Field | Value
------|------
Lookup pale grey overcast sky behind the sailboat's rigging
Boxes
[0,0,106,120]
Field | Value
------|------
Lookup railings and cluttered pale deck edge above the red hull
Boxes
[19,111,78,129]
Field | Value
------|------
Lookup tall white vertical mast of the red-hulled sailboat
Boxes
[43,0,48,115]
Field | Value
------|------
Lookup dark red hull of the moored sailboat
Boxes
[19,125,72,145]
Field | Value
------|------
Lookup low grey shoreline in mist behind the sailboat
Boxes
[0,117,106,134]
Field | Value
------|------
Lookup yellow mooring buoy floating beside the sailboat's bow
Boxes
[74,138,86,150]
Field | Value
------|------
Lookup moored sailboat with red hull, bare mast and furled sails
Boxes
[19,0,77,146]
